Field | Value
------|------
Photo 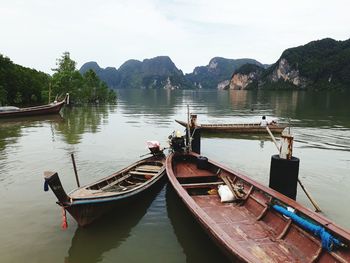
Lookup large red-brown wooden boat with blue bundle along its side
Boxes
[166,153,350,263]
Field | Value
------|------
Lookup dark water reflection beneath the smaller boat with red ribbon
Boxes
[65,180,164,263]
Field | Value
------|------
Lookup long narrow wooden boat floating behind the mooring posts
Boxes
[175,120,287,134]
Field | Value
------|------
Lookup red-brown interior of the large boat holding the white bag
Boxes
[172,155,350,262]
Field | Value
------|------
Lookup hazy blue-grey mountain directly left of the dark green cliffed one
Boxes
[186,57,264,89]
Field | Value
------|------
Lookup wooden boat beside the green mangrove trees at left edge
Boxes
[0,94,69,118]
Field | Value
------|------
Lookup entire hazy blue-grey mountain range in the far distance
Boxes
[80,56,264,89]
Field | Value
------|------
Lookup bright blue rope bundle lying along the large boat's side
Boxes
[272,205,342,252]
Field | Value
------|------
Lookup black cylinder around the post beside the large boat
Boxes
[269,154,300,200]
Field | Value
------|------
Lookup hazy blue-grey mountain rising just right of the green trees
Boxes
[80,56,192,89]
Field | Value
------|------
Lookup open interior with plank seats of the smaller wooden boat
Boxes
[69,161,164,199]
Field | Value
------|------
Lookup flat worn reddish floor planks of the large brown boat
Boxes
[192,195,320,262]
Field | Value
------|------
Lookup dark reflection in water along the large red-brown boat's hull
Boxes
[166,186,229,263]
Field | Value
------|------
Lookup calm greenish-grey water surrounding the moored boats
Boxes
[0,90,350,263]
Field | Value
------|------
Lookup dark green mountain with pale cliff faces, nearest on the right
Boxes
[230,38,350,90]
